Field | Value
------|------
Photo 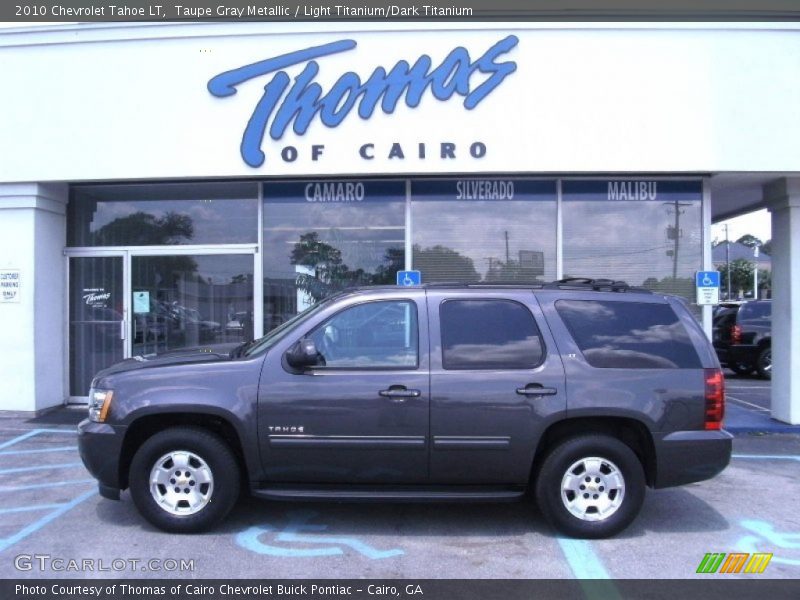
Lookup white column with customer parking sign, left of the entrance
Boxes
[0,183,67,412]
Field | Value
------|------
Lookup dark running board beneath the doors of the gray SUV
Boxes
[251,486,525,502]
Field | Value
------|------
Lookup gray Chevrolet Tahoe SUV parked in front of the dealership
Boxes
[79,280,731,538]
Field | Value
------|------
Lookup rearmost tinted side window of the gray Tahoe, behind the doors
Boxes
[556,300,701,369]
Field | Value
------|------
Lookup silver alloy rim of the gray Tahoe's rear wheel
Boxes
[561,456,625,521]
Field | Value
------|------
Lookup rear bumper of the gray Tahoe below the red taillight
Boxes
[654,430,733,488]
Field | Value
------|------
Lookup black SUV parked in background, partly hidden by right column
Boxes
[713,300,772,379]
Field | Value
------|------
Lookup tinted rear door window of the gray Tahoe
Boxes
[439,300,543,370]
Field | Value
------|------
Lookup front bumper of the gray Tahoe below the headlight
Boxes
[78,419,125,500]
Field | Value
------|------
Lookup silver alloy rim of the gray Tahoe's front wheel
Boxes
[150,450,214,516]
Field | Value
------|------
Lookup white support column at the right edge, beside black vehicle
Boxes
[764,178,800,425]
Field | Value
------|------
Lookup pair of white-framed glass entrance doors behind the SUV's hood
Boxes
[69,249,260,402]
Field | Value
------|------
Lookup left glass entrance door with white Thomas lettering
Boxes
[69,254,126,397]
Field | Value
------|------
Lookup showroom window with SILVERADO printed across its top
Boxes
[411,179,557,283]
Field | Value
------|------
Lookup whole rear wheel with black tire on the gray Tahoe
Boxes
[535,434,645,539]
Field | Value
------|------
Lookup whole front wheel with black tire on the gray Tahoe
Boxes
[129,427,240,533]
